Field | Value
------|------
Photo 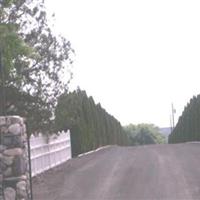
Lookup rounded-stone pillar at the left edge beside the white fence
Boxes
[0,116,30,200]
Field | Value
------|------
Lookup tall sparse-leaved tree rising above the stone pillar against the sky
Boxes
[0,0,74,134]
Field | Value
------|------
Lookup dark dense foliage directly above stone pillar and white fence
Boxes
[0,86,54,133]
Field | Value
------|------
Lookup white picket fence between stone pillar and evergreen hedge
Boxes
[30,131,71,176]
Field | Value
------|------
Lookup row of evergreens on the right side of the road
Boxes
[169,95,200,143]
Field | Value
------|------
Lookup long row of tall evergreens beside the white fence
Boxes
[55,89,128,156]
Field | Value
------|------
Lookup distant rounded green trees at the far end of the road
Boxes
[124,124,165,145]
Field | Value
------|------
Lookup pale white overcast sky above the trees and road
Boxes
[46,0,200,127]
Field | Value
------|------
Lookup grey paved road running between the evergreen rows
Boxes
[33,143,200,200]
